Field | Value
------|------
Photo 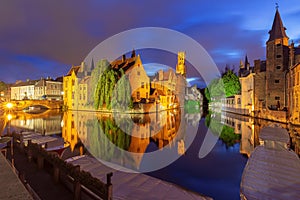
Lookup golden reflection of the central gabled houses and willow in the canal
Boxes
[62,109,201,170]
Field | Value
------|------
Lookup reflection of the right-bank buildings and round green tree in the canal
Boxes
[210,112,300,157]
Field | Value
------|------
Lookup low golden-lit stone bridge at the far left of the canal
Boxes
[10,100,63,111]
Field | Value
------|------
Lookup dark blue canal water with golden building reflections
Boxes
[0,110,282,199]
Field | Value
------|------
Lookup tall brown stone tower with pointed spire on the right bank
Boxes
[266,8,289,109]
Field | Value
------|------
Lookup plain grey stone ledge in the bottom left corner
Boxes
[0,153,32,200]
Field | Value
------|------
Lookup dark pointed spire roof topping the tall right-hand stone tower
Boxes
[268,9,288,41]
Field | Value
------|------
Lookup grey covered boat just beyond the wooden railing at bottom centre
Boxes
[67,156,211,200]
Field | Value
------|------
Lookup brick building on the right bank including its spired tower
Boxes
[234,8,300,123]
